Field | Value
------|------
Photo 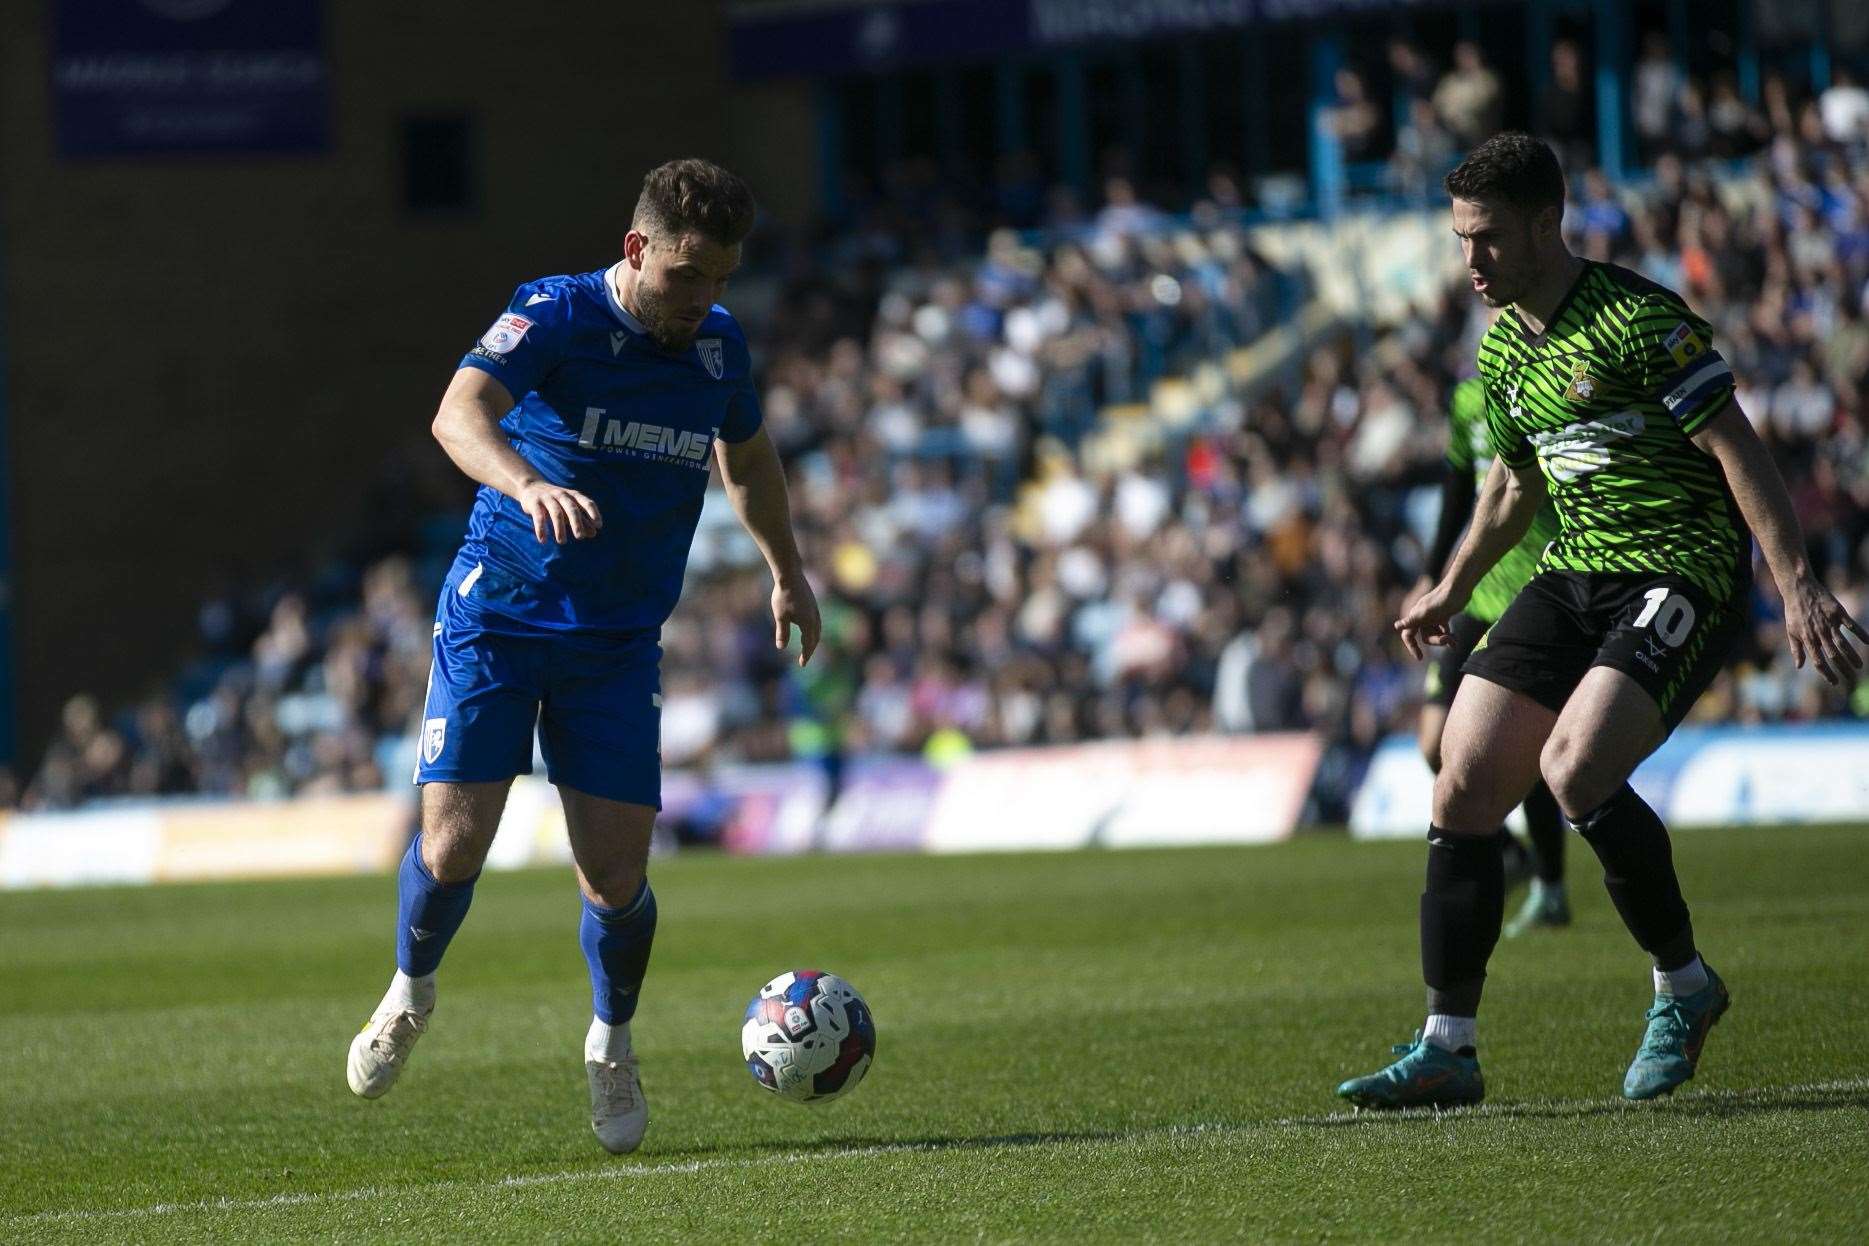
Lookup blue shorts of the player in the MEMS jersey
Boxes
[415,585,662,809]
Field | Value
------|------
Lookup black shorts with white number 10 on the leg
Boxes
[1463,572,1746,730]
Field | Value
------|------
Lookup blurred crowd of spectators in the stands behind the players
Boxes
[22,43,1869,818]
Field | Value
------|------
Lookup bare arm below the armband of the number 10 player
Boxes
[1693,402,1869,684]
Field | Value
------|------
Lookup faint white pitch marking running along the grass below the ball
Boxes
[0,1078,1869,1229]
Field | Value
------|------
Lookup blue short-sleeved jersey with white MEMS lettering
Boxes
[449,271,761,631]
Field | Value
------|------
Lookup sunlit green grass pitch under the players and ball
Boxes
[0,829,1869,1242]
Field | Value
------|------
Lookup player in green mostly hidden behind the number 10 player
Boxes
[1411,377,1570,938]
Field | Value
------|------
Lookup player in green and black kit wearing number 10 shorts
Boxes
[1338,135,1869,1108]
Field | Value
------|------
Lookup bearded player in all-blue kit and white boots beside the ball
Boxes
[348,161,819,1153]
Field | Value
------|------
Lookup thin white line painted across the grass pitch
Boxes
[0,1078,1869,1227]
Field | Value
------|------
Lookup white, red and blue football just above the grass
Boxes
[740,970,877,1104]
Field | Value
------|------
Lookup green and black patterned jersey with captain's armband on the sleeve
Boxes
[1480,263,1751,600]
